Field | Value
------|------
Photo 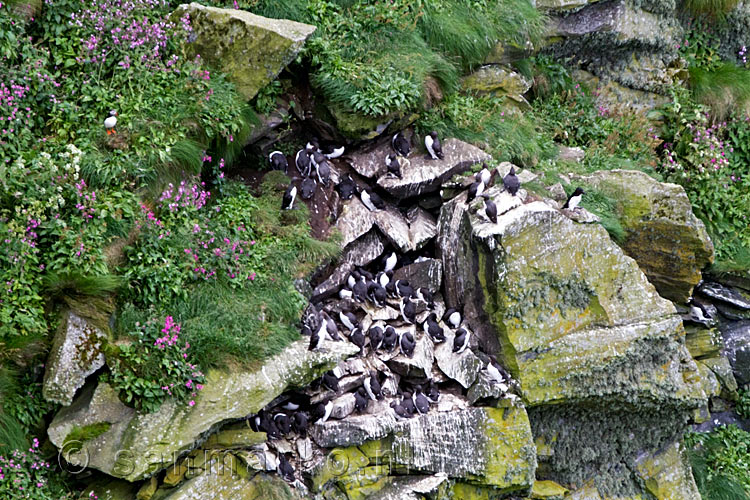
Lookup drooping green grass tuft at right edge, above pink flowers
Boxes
[689,62,750,121]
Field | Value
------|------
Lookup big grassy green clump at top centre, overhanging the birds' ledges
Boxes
[211,0,545,117]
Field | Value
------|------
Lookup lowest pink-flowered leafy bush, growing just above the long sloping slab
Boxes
[105,316,205,413]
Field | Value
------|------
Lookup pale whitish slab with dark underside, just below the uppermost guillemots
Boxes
[378,138,492,199]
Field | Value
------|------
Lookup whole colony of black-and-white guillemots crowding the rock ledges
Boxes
[244,132,584,482]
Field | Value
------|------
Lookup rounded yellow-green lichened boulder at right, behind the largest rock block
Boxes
[580,170,714,302]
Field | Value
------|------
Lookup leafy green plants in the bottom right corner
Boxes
[685,425,750,500]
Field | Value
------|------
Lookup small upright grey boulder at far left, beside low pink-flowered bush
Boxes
[42,309,107,406]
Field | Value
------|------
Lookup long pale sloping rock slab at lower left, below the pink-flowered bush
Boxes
[47,339,358,481]
